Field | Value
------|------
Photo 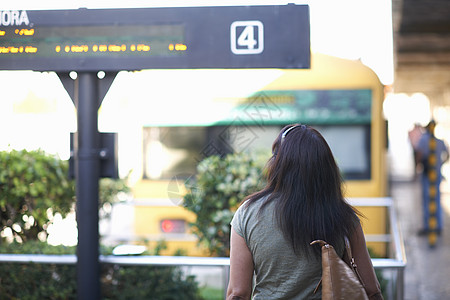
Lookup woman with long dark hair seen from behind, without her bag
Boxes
[227,124,382,300]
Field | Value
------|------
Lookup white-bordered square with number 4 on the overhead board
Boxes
[230,21,264,54]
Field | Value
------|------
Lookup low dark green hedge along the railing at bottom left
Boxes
[0,242,202,300]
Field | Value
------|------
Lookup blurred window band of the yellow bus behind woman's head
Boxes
[143,125,371,180]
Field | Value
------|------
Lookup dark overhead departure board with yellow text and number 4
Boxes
[0,4,310,71]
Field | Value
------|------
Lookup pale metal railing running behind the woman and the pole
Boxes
[0,198,406,300]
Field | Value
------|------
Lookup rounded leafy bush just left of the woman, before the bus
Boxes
[184,153,265,256]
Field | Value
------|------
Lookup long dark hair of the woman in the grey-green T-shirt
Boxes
[244,124,359,254]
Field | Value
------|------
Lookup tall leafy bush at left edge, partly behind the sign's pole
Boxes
[0,150,129,242]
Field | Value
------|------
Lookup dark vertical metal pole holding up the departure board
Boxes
[74,72,100,300]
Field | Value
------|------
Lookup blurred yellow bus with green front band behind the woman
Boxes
[125,53,387,256]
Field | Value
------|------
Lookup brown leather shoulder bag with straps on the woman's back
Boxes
[311,238,369,300]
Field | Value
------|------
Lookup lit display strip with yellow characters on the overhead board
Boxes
[0,25,187,58]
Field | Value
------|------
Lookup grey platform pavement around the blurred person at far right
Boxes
[390,179,450,300]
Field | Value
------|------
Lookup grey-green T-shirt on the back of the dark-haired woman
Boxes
[231,199,330,299]
